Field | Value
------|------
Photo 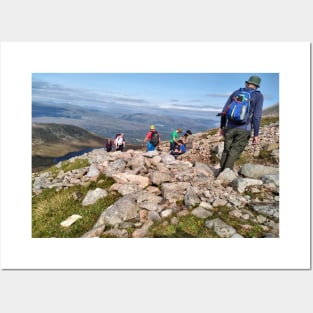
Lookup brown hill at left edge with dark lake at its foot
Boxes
[32,124,106,170]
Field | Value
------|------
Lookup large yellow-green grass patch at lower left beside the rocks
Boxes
[32,175,120,238]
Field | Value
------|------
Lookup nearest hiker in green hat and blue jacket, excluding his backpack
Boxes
[219,76,263,173]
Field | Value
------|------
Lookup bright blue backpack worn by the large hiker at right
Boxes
[224,88,256,124]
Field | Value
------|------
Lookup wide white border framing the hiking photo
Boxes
[1,42,311,269]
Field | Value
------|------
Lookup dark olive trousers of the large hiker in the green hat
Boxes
[220,128,250,171]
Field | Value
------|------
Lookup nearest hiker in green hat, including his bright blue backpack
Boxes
[218,76,263,173]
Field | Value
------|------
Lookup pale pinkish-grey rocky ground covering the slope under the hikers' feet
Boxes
[33,124,279,238]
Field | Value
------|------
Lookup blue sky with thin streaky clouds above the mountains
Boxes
[32,73,279,113]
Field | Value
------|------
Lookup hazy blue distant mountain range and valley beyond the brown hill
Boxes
[32,102,219,144]
